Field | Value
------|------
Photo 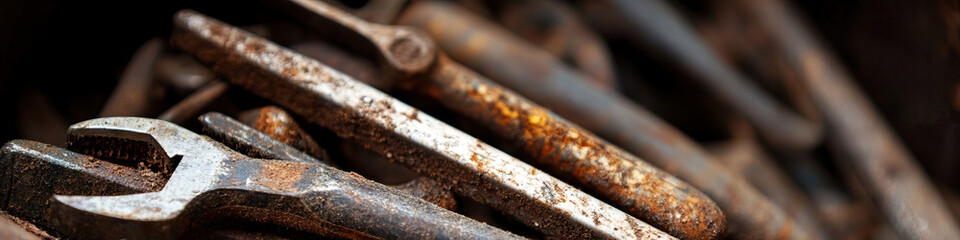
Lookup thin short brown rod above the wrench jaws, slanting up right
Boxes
[157,81,230,125]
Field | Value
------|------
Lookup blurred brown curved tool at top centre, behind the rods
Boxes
[499,0,618,89]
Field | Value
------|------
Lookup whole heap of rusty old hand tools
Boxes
[0,0,960,239]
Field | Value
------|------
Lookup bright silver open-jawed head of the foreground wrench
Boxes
[53,117,236,221]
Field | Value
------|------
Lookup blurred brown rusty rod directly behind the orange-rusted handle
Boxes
[399,1,817,239]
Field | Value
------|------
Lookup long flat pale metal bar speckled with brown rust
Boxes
[173,8,673,239]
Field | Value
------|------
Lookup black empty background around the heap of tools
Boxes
[0,0,960,191]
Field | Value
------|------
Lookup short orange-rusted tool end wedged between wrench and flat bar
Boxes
[240,106,332,166]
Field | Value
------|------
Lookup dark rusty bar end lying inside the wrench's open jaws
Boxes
[0,140,164,229]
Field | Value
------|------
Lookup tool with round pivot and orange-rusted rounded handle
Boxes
[219,1,725,239]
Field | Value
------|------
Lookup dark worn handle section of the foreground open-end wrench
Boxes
[290,165,520,239]
